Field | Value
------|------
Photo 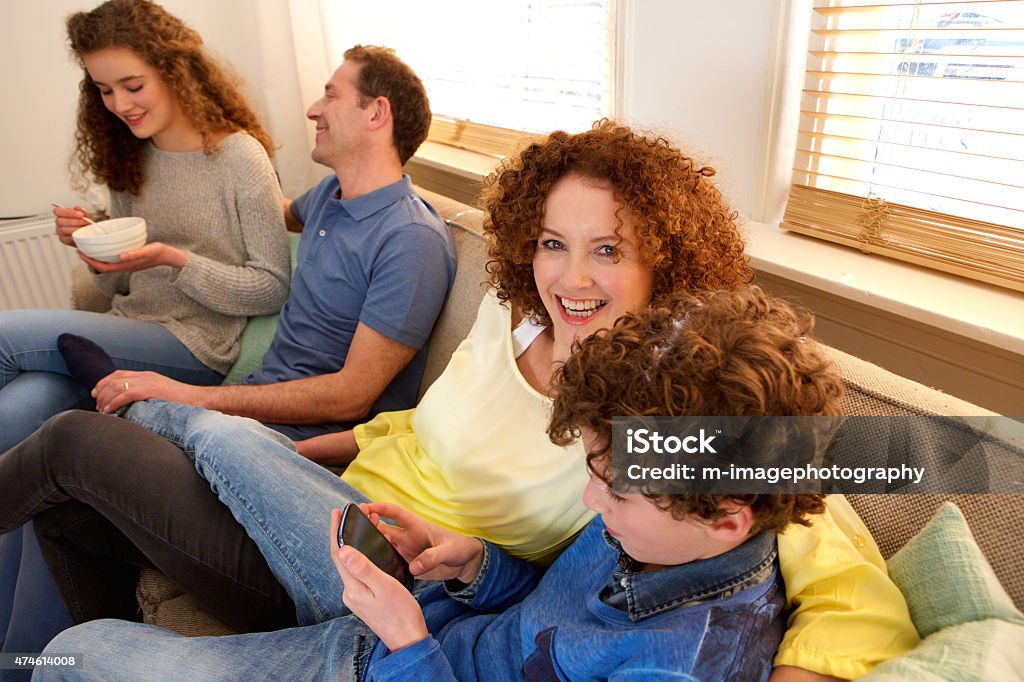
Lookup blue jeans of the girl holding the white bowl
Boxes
[0,310,223,453]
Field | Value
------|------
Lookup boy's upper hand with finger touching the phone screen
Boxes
[359,502,483,585]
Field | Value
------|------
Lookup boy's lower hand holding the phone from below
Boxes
[329,509,429,651]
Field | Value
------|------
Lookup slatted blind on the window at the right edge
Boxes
[782,0,1024,291]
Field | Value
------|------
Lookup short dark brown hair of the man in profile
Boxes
[345,45,431,165]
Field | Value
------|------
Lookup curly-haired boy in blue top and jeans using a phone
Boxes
[37,288,842,680]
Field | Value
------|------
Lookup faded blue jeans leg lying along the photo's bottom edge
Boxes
[33,615,375,682]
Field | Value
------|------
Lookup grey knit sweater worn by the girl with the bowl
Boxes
[93,132,291,374]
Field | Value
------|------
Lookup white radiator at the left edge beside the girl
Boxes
[0,213,82,310]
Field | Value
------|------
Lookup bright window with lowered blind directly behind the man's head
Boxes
[325,0,615,155]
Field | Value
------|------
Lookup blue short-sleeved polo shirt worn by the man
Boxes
[244,175,456,438]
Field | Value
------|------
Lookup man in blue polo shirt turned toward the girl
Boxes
[88,46,455,439]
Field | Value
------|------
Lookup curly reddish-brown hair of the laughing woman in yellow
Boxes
[481,119,754,324]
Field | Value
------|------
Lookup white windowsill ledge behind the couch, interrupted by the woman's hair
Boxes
[407,142,1024,356]
